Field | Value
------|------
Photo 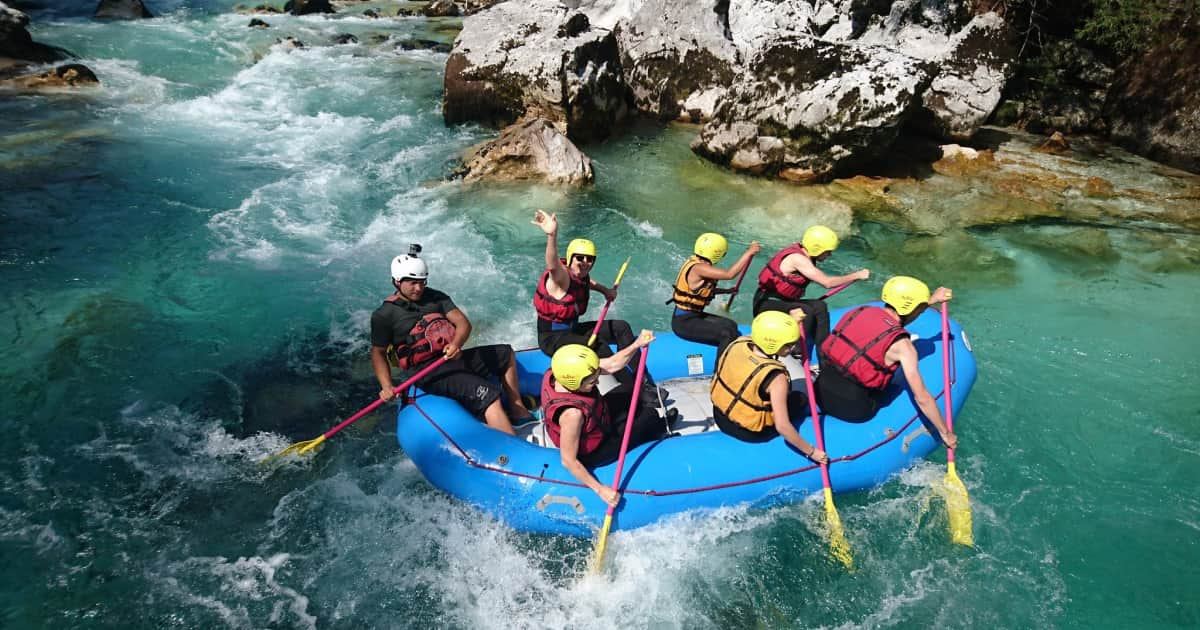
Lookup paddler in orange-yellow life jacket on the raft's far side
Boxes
[667,232,762,356]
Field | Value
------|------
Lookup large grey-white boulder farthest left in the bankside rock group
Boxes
[442,0,630,142]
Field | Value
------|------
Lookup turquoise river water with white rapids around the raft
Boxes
[0,0,1200,629]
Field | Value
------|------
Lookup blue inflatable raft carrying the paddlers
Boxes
[396,303,976,536]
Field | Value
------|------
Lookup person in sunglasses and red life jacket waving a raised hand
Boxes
[533,210,668,402]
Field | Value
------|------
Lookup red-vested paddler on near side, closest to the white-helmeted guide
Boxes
[541,330,666,505]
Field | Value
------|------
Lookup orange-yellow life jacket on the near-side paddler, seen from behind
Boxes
[708,337,787,432]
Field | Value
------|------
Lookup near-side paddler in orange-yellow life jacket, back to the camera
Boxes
[709,308,829,463]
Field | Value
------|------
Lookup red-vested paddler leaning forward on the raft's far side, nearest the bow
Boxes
[754,226,871,346]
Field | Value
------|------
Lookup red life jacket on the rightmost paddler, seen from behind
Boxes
[821,306,908,390]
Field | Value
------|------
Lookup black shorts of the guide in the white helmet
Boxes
[418,343,514,418]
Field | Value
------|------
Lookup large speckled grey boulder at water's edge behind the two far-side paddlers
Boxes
[691,36,934,182]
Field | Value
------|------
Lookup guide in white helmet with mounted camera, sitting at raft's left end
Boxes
[371,245,530,434]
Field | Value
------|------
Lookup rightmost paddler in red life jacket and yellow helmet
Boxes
[816,276,958,449]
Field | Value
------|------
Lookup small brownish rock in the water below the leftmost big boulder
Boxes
[457,119,593,186]
